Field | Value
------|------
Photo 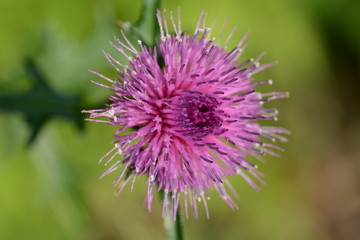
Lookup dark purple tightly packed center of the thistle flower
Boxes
[179,92,222,137]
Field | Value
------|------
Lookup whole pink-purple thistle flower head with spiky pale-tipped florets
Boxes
[84,11,288,218]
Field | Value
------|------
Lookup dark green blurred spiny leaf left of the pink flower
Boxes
[0,59,83,144]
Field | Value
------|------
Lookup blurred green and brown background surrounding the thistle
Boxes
[0,0,360,240]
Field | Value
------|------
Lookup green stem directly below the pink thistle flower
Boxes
[160,191,184,240]
